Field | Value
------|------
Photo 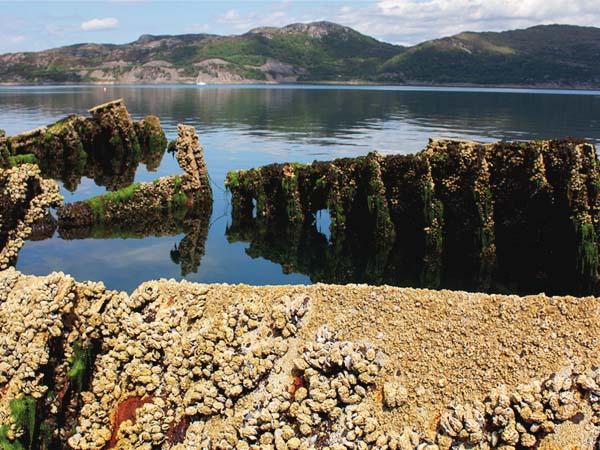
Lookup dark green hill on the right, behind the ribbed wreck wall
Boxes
[379,25,600,86]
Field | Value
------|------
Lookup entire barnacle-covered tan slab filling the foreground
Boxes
[0,269,600,450]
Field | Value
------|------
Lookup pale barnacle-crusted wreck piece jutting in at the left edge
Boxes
[0,164,62,270]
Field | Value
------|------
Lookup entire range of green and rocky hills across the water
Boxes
[0,22,600,87]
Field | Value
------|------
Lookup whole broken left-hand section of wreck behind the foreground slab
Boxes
[0,100,212,274]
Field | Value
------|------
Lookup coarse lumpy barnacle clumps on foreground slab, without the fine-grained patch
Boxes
[0,268,600,450]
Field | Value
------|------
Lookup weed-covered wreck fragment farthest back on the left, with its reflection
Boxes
[5,99,167,190]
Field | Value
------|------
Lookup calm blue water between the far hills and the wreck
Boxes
[0,86,600,290]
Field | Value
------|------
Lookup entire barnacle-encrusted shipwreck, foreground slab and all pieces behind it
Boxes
[0,101,600,450]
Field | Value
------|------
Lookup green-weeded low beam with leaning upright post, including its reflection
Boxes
[58,118,212,276]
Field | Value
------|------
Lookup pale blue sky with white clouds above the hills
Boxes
[0,0,600,53]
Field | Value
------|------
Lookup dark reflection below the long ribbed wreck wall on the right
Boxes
[226,214,579,294]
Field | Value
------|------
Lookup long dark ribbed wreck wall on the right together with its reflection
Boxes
[227,141,600,294]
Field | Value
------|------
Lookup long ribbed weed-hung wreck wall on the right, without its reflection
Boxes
[226,140,600,293]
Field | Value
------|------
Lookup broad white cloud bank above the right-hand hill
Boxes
[334,0,600,44]
